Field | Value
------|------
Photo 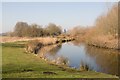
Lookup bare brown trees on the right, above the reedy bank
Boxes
[68,4,120,38]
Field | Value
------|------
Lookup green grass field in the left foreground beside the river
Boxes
[2,42,117,78]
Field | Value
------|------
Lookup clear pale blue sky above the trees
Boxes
[2,2,113,32]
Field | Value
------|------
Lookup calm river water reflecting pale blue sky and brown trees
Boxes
[38,41,120,75]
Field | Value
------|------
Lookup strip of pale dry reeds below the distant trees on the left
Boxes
[0,36,74,45]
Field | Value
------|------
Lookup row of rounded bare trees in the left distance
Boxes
[9,22,62,37]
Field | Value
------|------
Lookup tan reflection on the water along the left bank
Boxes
[38,44,68,65]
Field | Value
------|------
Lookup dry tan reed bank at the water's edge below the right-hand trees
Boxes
[75,35,120,50]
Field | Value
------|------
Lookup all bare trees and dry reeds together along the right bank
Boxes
[69,4,119,49]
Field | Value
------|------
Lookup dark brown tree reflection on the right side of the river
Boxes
[86,46,118,75]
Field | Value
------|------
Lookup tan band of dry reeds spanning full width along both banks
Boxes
[0,36,120,50]
